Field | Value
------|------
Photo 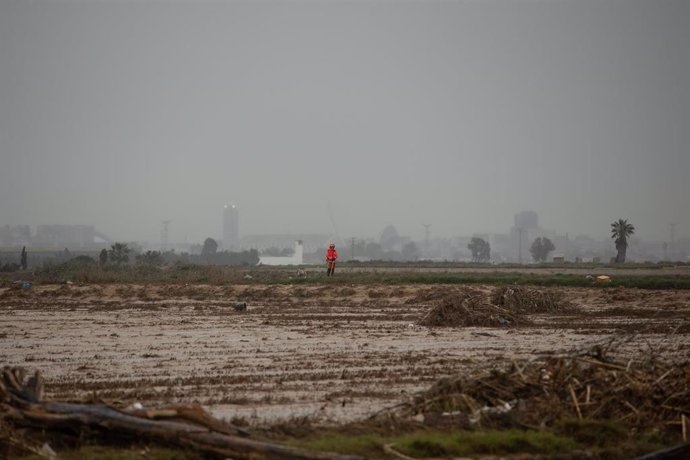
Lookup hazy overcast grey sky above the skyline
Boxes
[0,0,690,242]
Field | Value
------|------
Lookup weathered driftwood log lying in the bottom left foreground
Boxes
[0,367,359,460]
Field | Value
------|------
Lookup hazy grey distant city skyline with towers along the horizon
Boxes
[0,209,690,263]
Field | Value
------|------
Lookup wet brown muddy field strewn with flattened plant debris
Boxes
[0,284,690,425]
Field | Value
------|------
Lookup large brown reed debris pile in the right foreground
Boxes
[396,354,690,434]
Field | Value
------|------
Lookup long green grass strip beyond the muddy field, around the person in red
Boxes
[5,262,690,289]
